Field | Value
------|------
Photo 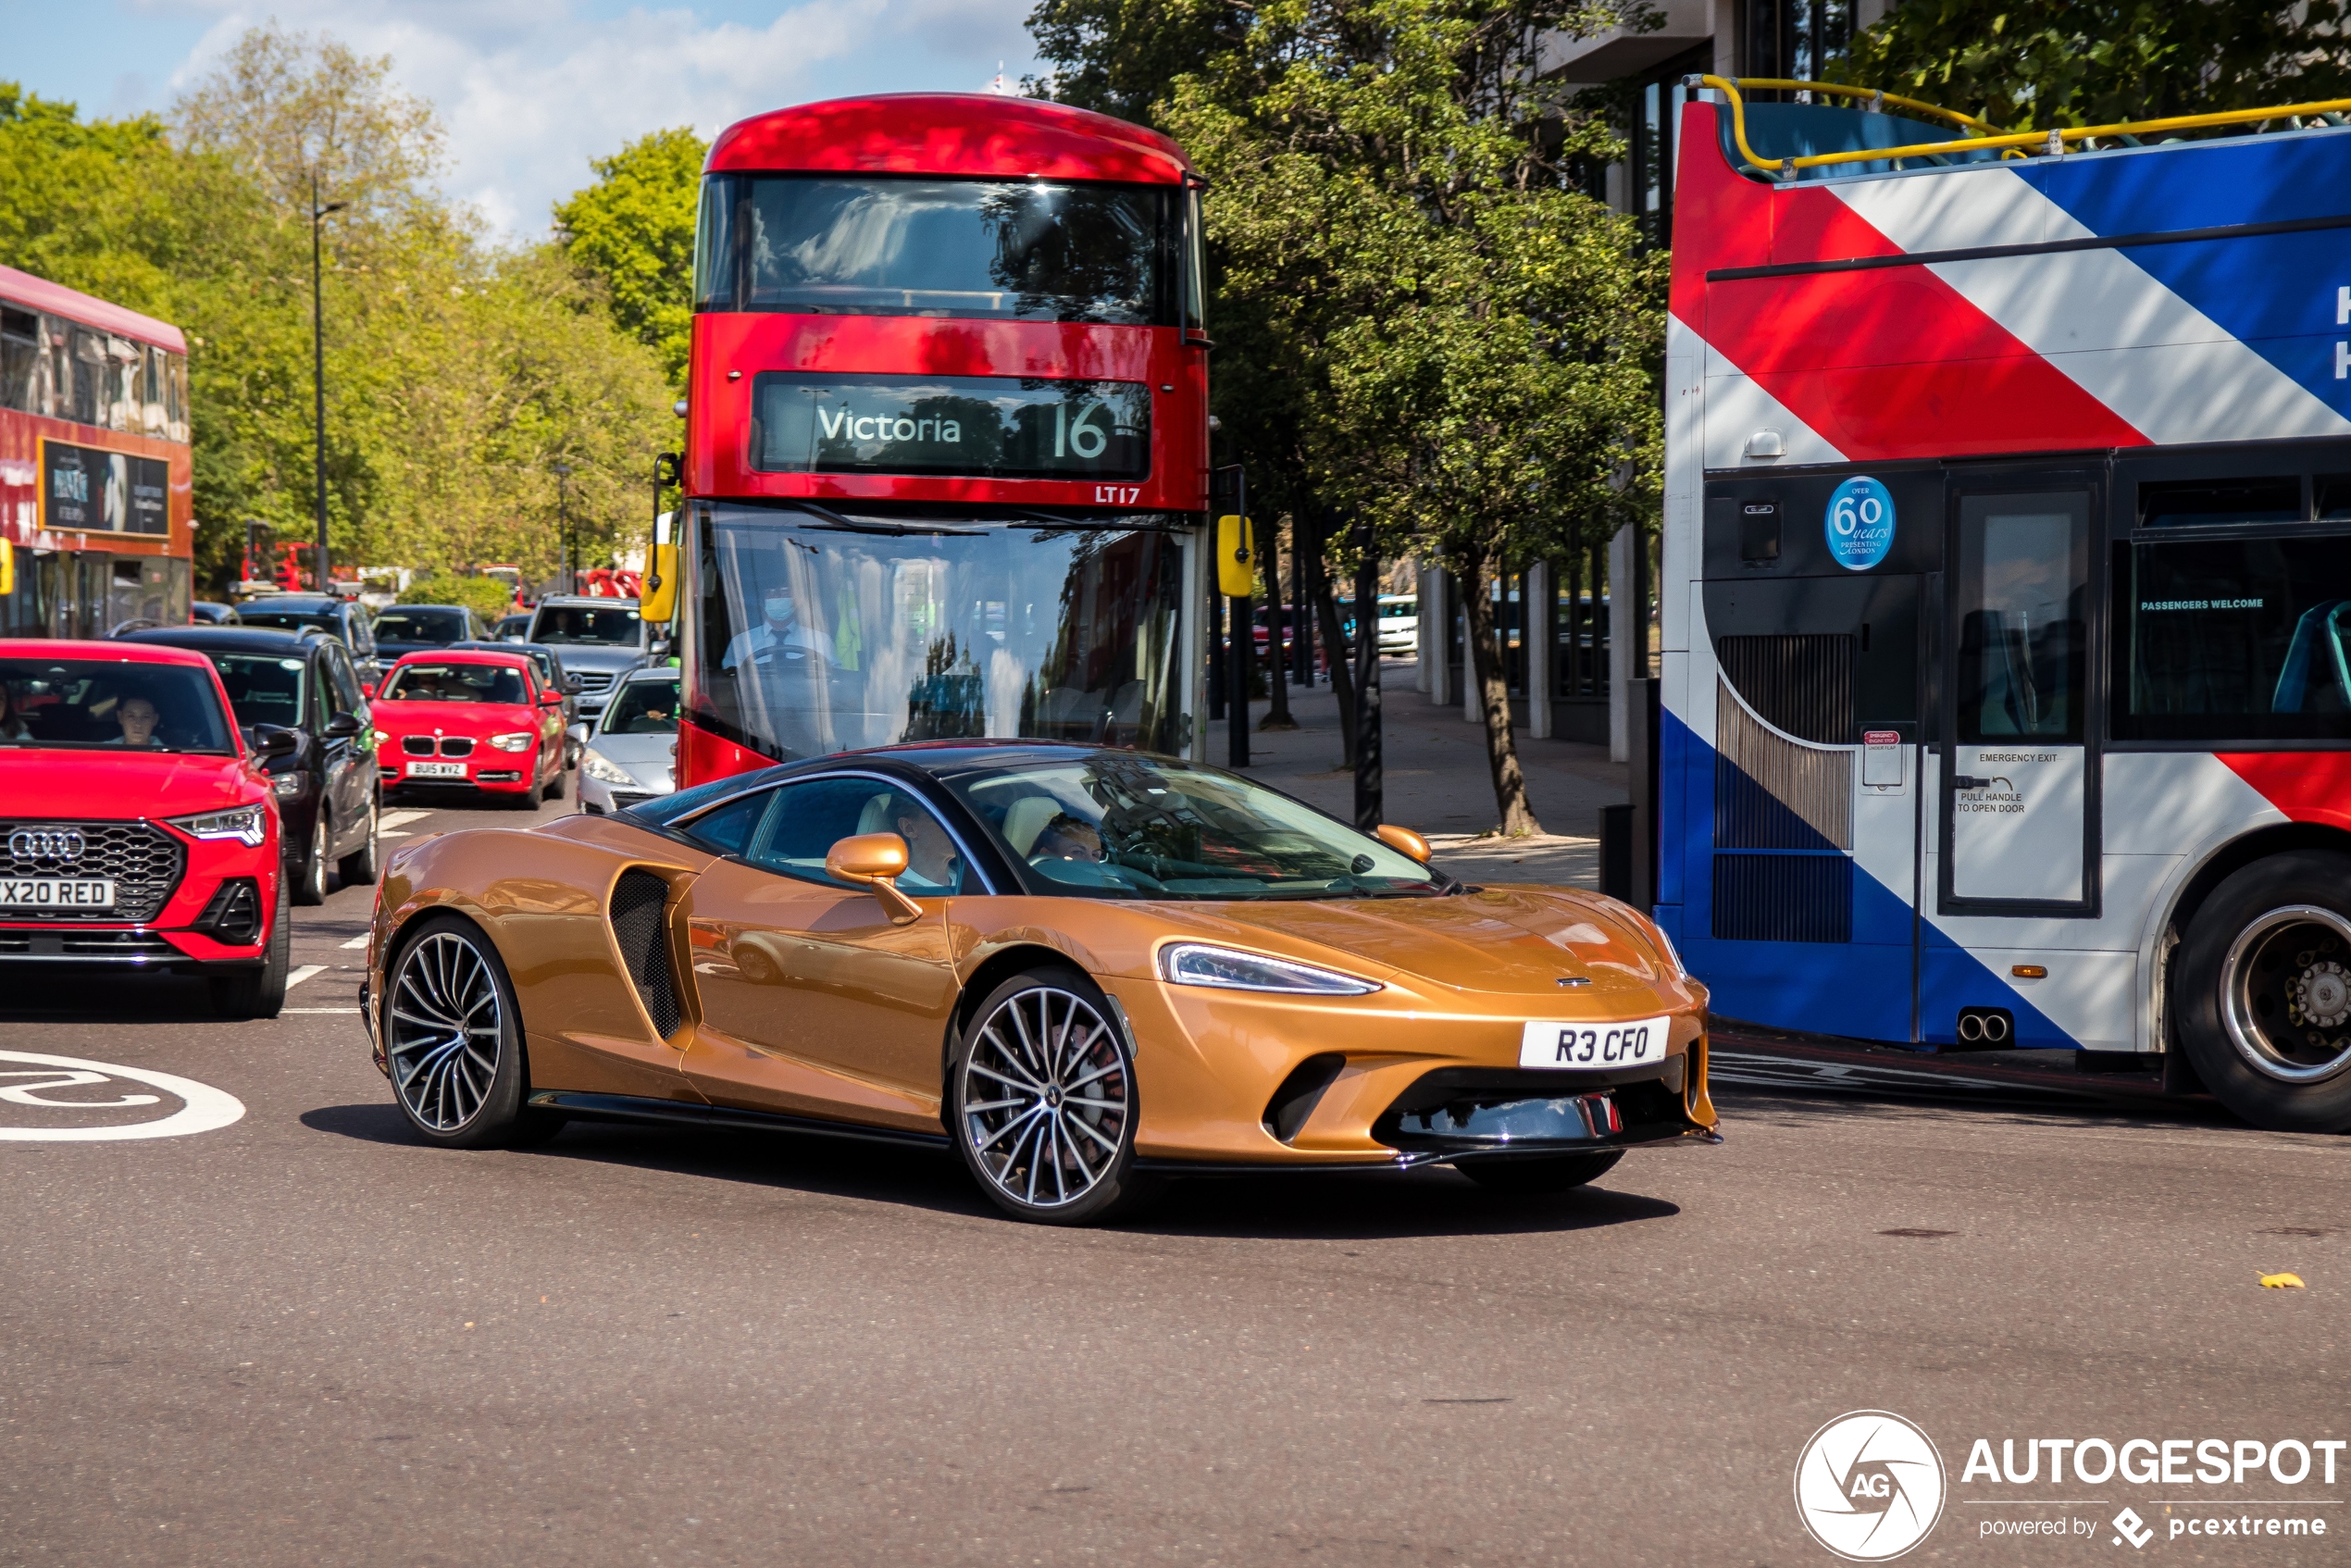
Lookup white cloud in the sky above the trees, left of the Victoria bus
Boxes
[160,0,1035,240]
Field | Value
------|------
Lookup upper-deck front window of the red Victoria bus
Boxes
[693,174,1176,327]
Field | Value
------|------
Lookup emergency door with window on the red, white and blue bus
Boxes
[1942,484,2097,915]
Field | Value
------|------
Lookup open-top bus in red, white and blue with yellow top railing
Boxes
[1655,78,2351,1131]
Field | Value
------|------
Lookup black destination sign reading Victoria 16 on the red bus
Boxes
[750,371,1152,479]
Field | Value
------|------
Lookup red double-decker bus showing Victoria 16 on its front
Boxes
[647,94,1213,785]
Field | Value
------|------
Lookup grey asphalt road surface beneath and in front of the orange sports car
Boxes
[0,806,2351,1568]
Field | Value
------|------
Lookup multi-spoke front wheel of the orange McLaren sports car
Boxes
[957,985,1136,1211]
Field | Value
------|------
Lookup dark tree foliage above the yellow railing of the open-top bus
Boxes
[1832,0,2351,130]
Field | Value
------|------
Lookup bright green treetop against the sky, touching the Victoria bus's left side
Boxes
[554,127,710,383]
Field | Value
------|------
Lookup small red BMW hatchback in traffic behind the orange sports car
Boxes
[374,649,565,809]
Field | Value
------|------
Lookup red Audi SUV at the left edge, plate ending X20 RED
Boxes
[0,640,292,1018]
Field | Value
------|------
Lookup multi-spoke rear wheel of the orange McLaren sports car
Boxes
[383,931,505,1133]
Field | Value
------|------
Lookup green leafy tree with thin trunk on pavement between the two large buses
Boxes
[1081,0,1664,835]
